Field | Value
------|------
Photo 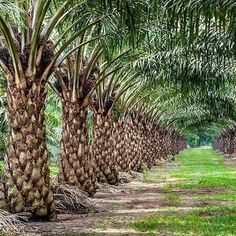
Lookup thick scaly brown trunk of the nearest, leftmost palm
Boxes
[5,85,54,219]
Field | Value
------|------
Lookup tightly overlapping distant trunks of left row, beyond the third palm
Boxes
[102,112,186,172]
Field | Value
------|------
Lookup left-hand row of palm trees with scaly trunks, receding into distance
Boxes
[0,0,186,219]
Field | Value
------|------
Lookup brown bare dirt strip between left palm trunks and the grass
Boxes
[23,152,234,235]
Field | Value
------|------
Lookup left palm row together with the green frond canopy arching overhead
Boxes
[0,0,235,222]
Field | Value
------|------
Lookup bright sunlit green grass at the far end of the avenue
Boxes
[165,149,236,190]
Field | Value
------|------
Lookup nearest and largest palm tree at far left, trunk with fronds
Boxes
[0,0,102,219]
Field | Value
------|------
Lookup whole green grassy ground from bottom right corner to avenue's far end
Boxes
[132,149,236,236]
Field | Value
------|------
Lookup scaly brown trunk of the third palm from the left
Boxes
[93,114,118,184]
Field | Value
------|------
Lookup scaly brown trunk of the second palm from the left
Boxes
[59,101,96,194]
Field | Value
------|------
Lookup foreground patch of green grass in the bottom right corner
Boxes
[132,207,236,236]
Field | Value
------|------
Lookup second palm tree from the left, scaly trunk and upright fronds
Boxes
[53,36,125,194]
